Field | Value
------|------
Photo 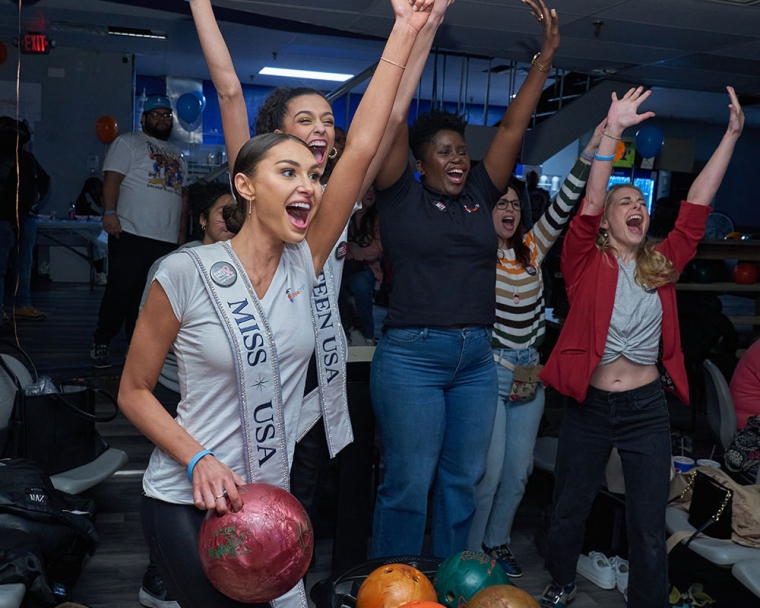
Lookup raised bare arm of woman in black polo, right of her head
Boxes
[483,0,559,190]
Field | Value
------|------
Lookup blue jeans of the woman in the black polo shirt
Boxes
[370,327,498,557]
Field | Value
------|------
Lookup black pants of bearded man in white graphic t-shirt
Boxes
[92,232,177,344]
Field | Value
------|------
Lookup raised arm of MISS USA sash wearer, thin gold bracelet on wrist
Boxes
[306,0,436,272]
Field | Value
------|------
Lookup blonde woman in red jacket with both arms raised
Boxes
[540,87,744,608]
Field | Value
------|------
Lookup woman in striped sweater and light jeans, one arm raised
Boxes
[468,123,604,578]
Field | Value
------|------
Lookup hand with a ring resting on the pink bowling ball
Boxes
[193,454,245,515]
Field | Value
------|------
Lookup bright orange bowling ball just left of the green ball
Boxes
[356,564,438,608]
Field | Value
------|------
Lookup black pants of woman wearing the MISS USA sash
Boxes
[141,496,269,608]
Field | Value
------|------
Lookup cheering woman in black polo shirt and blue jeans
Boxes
[371,0,559,557]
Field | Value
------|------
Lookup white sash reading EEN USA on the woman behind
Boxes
[298,259,354,458]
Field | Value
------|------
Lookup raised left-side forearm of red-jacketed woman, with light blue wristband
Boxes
[581,87,654,215]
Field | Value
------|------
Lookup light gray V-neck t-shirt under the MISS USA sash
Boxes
[143,241,316,505]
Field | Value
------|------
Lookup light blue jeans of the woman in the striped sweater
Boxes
[467,348,544,551]
